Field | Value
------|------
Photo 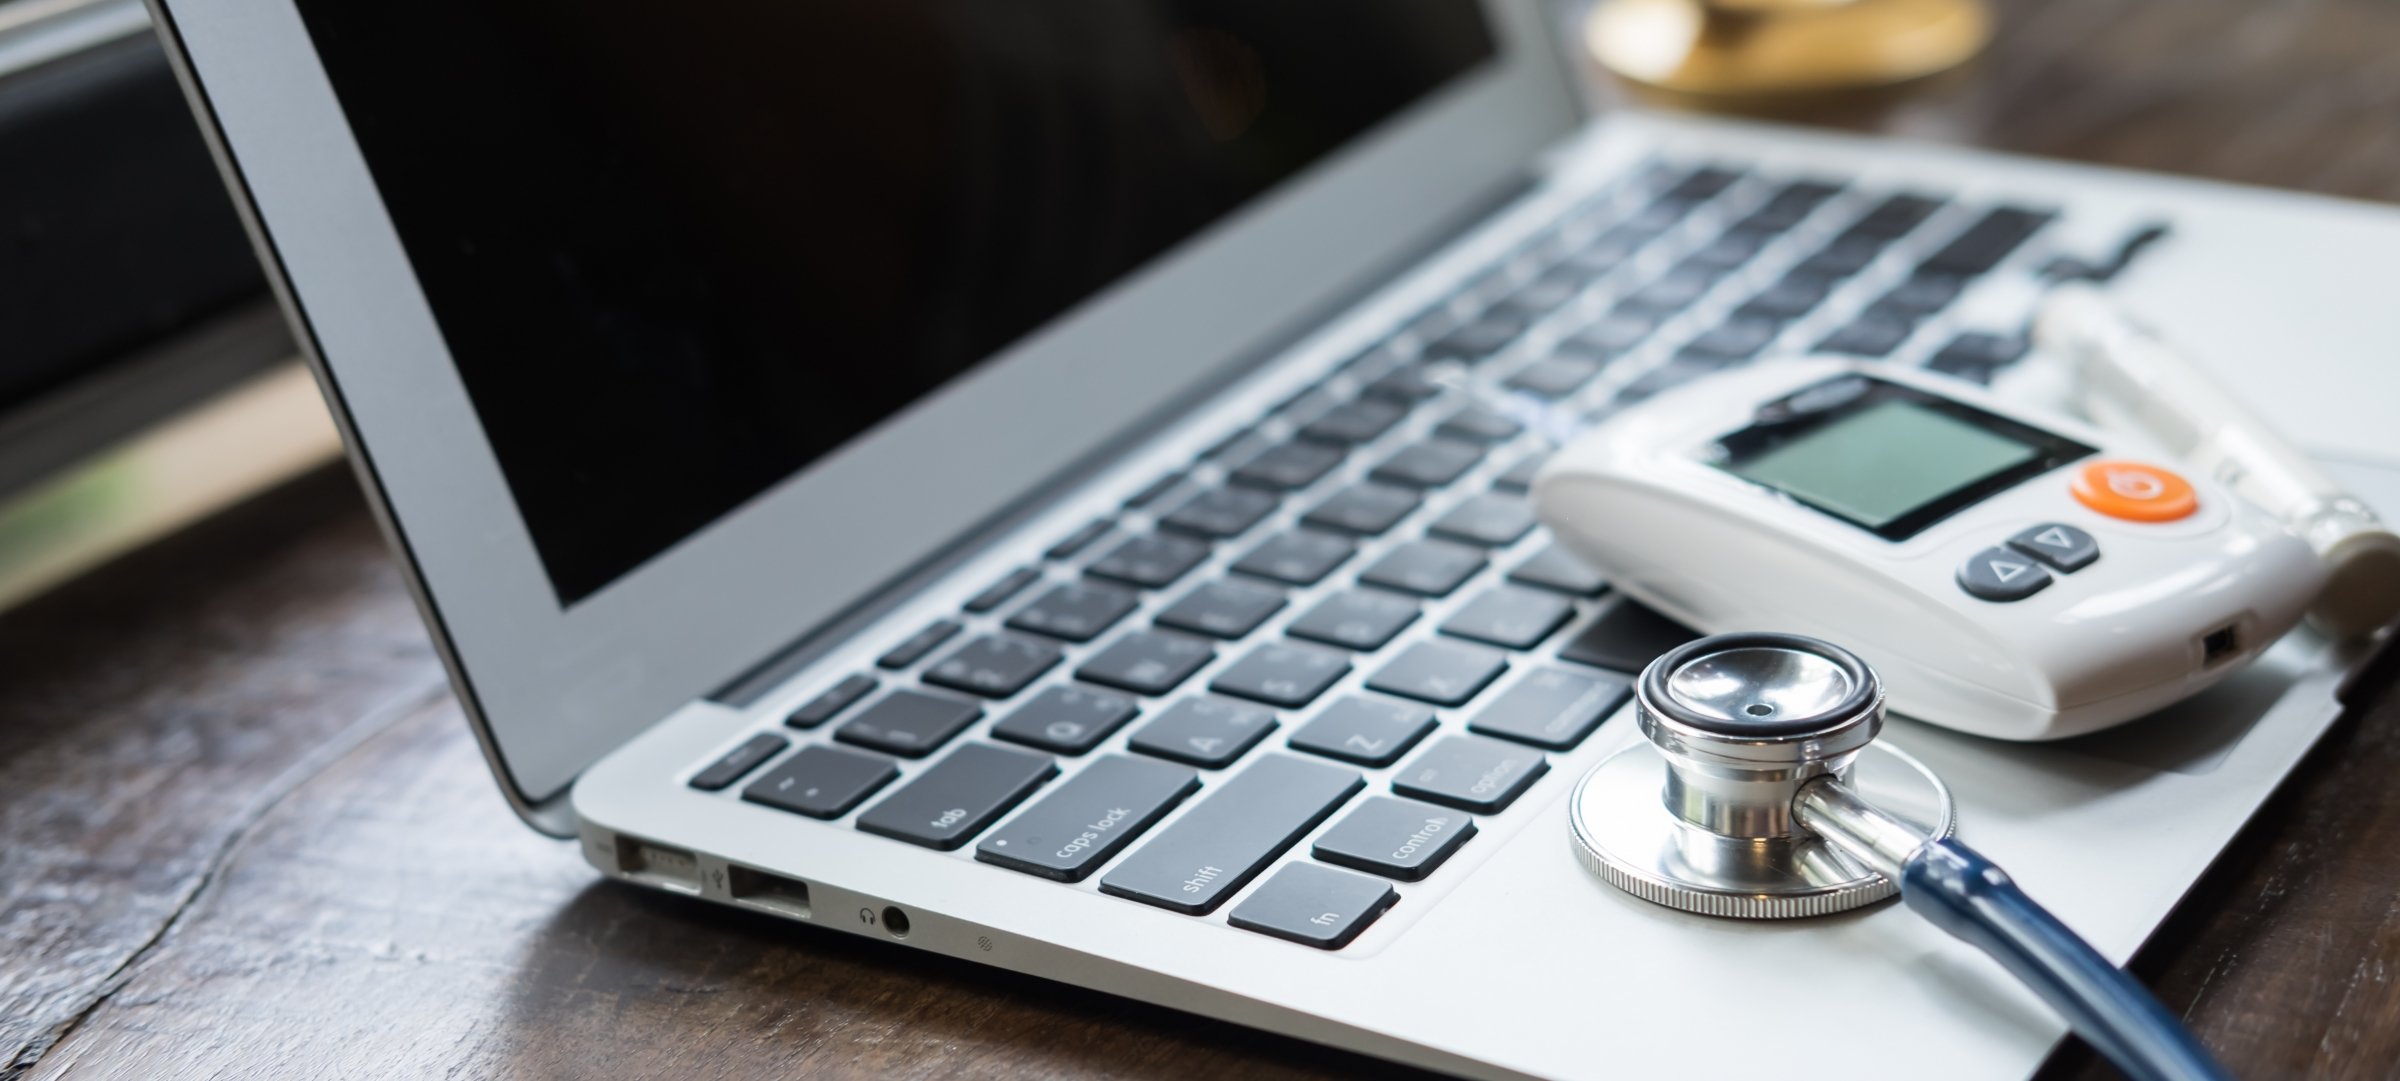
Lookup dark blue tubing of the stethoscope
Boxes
[1901,838,2232,1081]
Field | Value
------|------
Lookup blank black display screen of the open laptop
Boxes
[300,0,1493,605]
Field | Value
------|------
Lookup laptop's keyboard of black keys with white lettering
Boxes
[689,166,2050,949]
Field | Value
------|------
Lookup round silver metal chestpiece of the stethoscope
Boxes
[1567,632,1954,918]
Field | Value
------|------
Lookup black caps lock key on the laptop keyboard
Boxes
[974,754,1200,882]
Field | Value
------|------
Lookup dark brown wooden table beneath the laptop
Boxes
[0,0,2400,1081]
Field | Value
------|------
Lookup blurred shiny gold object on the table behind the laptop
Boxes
[1584,0,1992,96]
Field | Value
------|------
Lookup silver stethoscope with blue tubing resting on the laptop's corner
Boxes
[1570,634,2227,1081]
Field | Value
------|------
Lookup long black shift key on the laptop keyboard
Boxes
[1099,754,1366,915]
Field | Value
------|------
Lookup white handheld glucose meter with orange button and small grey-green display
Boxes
[1534,358,2326,740]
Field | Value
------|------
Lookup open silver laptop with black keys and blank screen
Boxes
[156,0,2400,1079]
